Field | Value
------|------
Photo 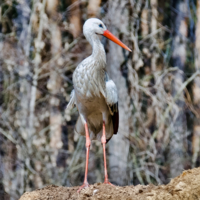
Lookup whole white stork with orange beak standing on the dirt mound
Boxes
[67,18,131,192]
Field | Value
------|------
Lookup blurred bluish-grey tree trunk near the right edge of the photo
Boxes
[169,0,188,177]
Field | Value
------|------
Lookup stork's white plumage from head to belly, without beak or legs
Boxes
[68,18,118,140]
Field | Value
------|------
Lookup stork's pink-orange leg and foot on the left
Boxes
[77,123,91,192]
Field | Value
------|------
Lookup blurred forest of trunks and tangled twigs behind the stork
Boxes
[0,0,200,200]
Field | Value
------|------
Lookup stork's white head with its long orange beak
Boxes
[83,18,131,51]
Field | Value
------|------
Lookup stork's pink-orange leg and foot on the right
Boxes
[101,122,113,185]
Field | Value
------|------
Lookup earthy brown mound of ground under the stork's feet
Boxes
[20,167,200,200]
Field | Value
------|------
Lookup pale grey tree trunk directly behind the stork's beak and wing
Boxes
[107,1,131,185]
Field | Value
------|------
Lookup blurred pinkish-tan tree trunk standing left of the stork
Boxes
[47,0,63,166]
